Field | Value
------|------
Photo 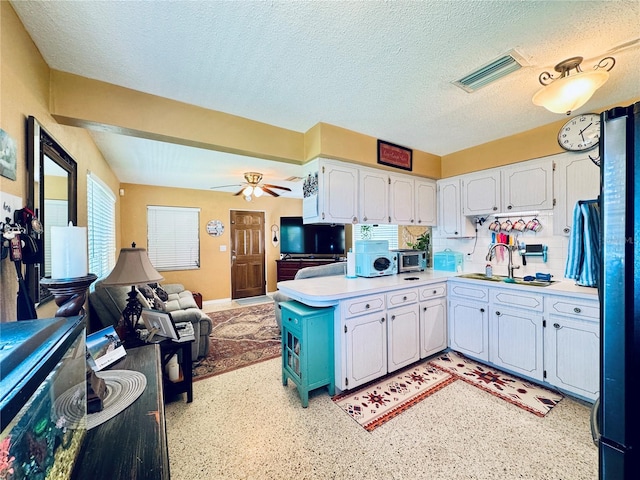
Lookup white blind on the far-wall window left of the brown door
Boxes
[147,206,200,271]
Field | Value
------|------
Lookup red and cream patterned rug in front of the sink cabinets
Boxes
[429,351,564,417]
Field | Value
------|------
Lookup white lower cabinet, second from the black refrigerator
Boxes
[489,289,544,381]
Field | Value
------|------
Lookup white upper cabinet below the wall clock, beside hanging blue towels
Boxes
[553,150,600,235]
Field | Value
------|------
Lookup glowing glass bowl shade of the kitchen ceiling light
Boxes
[532,70,609,114]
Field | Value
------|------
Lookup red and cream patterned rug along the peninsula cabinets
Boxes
[332,363,455,432]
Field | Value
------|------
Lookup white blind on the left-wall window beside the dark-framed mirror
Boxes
[87,173,116,284]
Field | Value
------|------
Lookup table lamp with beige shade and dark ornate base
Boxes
[102,243,164,345]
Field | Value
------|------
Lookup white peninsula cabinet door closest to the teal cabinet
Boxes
[336,311,387,390]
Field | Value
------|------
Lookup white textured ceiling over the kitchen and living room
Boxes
[12,0,640,195]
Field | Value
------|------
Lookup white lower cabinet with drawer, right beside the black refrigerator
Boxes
[544,296,600,400]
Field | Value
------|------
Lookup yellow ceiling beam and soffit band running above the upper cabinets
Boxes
[50,70,440,178]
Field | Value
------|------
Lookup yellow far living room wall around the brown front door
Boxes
[120,184,302,300]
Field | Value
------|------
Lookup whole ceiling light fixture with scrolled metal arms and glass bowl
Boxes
[532,57,616,115]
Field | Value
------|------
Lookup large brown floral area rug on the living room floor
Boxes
[193,303,282,381]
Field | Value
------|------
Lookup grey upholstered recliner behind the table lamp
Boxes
[89,280,212,361]
